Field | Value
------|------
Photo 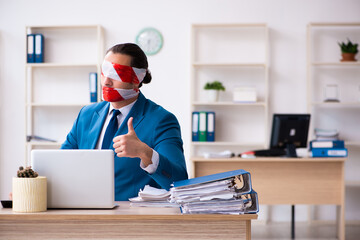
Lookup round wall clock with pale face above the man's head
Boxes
[136,27,164,55]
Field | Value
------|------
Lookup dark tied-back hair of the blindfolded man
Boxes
[106,43,152,87]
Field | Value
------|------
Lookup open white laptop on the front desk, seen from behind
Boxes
[31,149,115,208]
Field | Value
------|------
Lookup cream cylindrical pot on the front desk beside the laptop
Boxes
[12,176,47,213]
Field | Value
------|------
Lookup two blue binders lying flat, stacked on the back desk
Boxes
[310,140,348,157]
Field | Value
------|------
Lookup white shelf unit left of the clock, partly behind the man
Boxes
[25,25,104,165]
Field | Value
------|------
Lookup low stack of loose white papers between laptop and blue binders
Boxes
[129,185,179,207]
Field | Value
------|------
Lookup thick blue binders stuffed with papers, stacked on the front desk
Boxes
[170,169,259,214]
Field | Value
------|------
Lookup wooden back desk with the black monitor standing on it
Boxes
[192,158,346,240]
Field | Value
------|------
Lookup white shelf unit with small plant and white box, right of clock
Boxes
[190,24,269,177]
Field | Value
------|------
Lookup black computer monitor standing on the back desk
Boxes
[270,114,310,157]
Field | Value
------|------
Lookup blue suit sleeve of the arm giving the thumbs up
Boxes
[149,114,188,189]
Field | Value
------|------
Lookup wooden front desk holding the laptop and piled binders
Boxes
[0,202,257,240]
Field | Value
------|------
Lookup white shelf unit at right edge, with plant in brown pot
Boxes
[307,23,360,188]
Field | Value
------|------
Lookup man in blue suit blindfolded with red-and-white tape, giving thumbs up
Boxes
[61,43,188,201]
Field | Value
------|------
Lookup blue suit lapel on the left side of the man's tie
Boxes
[88,103,110,149]
